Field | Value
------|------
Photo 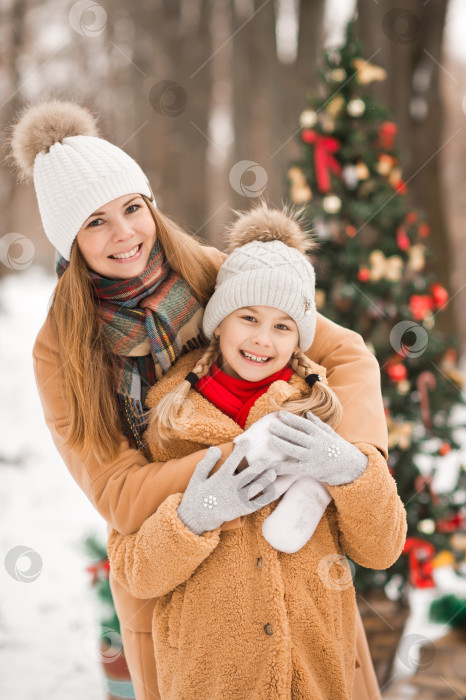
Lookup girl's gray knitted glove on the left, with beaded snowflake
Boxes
[177,441,281,535]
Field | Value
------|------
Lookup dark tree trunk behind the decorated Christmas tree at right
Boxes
[358,0,458,331]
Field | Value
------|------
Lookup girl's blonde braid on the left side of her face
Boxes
[147,335,220,442]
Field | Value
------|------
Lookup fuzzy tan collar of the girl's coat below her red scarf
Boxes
[146,348,327,445]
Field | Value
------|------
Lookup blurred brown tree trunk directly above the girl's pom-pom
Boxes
[231,0,324,207]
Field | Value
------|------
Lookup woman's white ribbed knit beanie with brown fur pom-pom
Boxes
[6,100,155,260]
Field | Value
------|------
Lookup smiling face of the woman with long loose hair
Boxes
[76,194,156,280]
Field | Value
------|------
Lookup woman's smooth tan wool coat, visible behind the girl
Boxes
[32,242,388,700]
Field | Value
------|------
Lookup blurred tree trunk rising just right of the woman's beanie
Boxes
[117,0,211,235]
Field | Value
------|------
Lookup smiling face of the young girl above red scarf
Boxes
[215,306,299,382]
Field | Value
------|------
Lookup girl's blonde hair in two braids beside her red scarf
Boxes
[146,336,343,443]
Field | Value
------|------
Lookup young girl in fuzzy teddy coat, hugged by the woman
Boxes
[108,207,407,700]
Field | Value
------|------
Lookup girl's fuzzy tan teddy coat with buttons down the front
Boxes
[108,349,407,700]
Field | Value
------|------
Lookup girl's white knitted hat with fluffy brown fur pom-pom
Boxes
[203,204,316,351]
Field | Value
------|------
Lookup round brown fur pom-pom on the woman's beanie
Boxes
[7,100,99,180]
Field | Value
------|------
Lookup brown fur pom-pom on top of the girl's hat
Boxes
[228,201,318,255]
